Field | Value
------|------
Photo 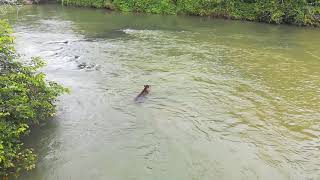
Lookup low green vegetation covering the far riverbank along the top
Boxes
[61,0,320,26]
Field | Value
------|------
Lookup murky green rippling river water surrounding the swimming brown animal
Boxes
[5,5,320,180]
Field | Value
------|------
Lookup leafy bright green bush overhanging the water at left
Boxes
[0,20,67,178]
